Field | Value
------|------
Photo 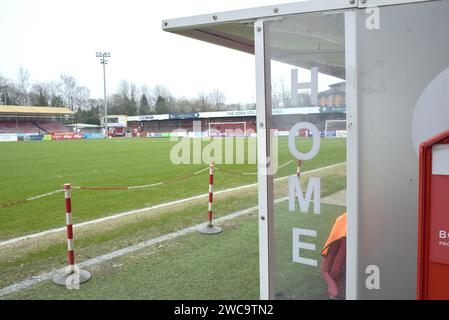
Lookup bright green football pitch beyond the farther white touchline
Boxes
[0,138,346,241]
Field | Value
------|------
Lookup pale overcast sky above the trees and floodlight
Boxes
[0,0,336,103]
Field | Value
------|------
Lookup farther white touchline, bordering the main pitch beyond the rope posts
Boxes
[0,162,346,247]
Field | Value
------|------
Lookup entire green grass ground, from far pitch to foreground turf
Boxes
[0,138,346,299]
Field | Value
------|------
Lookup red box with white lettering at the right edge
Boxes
[417,130,449,300]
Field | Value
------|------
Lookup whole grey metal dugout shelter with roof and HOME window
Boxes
[162,0,449,299]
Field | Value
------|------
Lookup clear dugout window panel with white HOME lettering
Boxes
[265,12,347,299]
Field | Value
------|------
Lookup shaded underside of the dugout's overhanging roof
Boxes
[169,13,345,79]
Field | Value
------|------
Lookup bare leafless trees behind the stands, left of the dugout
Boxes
[0,67,255,124]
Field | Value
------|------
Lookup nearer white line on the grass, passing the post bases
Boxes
[0,197,288,297]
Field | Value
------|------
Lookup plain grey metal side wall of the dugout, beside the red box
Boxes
[357,1,449,299]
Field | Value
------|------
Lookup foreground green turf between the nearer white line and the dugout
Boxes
[7,203,341,300]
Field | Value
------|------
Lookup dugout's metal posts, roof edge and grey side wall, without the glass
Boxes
[162,0,449,299]
